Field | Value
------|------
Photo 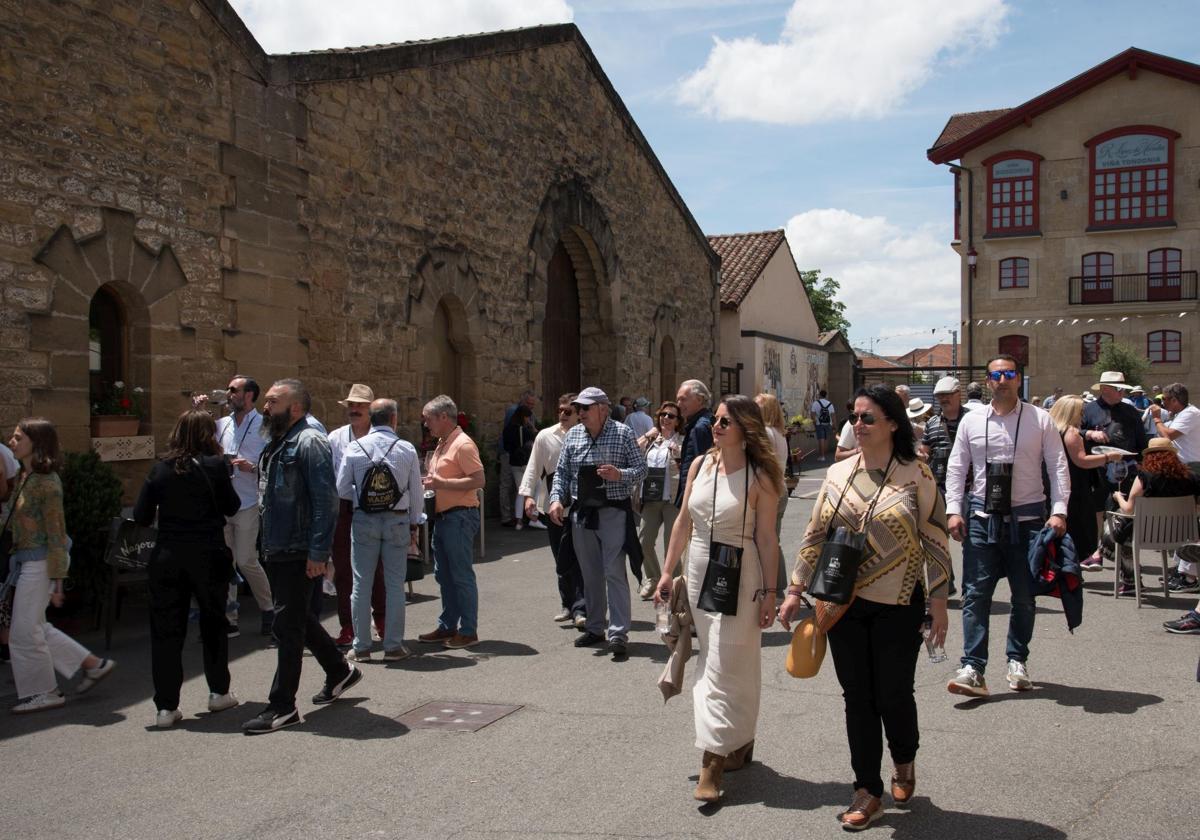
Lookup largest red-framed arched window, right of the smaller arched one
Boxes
[1084,126,1180,227]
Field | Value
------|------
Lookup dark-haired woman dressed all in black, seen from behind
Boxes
[133,409,241,728]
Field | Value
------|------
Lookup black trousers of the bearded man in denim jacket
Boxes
[263,551,350,712]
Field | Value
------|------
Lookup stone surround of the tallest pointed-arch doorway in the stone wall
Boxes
[527,178,625,400]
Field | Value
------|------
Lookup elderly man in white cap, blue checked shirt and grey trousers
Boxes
[548,388,646,659]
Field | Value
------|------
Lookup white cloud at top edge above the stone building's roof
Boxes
[230,0,575,53]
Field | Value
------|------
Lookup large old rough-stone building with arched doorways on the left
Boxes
[0,0,719,494]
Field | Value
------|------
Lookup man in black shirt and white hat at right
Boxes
[1080,371,1150,569]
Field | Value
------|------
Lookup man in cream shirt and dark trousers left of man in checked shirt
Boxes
[517,394,587,629]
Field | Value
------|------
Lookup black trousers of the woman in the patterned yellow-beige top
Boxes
[829,587,925,797]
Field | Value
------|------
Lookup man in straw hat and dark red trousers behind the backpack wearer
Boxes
[329,383,386,648]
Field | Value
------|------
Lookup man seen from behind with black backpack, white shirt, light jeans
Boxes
[337,400,425,662]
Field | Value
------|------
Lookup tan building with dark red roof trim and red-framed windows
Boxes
[928,49,1200,395]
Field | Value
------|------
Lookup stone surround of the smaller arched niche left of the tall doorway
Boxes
[401,248,485,432]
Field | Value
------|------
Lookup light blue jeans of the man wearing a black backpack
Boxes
[350,510,408,653]
